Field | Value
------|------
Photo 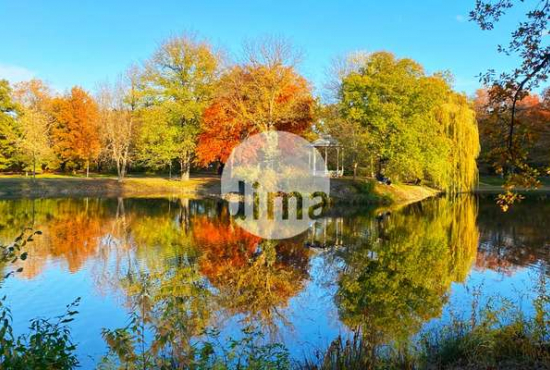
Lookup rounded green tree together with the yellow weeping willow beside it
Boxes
[336,52,479,193]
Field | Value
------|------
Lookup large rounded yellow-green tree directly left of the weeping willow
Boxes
[339,53,429,184]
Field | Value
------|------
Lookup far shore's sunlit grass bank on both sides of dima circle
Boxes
[0,174,438,205]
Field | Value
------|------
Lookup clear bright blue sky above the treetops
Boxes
[0,0,532,94]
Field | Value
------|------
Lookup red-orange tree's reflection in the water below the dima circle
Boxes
[193,213,309,328]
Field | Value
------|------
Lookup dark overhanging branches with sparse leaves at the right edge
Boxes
[470,0,550,208]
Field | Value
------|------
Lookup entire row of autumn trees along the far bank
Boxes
[0,33,520,199]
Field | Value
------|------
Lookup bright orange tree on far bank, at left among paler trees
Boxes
[52,87,101,177]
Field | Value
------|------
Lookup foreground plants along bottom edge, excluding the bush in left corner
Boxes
[100,276,550,370]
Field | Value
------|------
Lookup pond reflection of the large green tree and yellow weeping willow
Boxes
[336,198,479,343]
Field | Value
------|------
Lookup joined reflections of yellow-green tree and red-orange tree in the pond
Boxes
[103,201,308,361]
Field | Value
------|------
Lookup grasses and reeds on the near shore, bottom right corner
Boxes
[302,282,550,370]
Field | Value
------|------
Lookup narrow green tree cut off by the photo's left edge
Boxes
[0,80,18,169]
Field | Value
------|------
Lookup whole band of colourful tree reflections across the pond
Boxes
[0,197,550,352]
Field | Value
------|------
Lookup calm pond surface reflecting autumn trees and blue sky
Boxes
[0,196,550,368]
